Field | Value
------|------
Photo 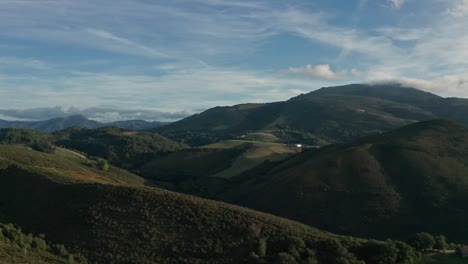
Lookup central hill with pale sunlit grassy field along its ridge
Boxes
[136,140,301,198]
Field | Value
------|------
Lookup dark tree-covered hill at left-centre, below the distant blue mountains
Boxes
[54,127,185,169]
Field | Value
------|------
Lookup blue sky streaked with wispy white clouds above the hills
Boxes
[0,0,468,121]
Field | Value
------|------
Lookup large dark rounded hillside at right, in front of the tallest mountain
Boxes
[220,120,468,243]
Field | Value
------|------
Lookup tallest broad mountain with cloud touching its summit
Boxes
[152,84,468,146]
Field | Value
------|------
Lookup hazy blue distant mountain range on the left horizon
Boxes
[0,115,168,133]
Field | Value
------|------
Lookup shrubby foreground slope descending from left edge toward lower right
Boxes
[0,145,414,264]
